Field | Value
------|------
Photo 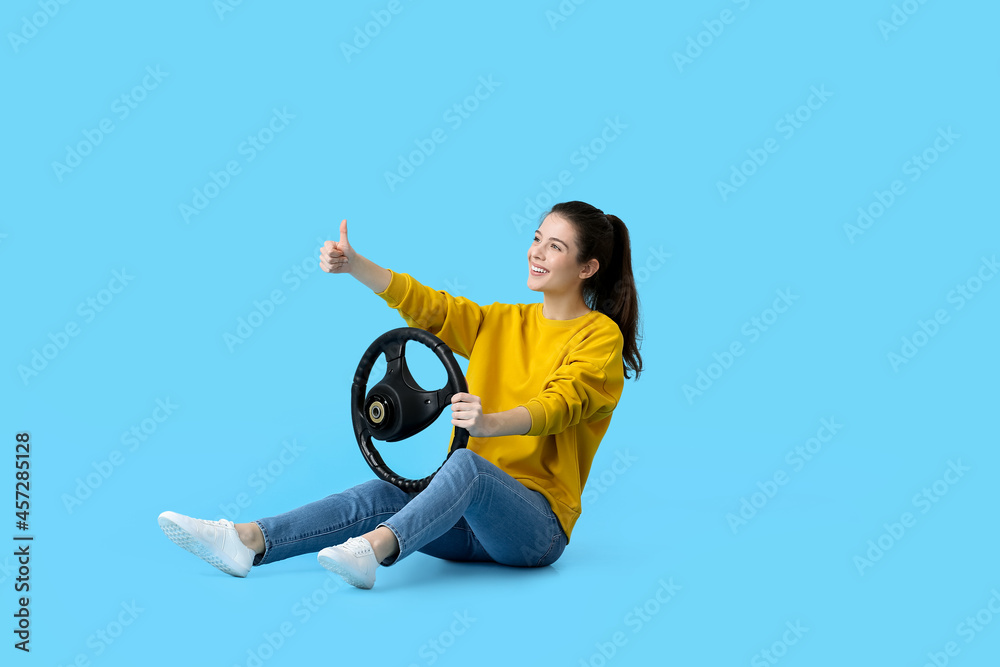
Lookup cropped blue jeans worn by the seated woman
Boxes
[254,449,567,567]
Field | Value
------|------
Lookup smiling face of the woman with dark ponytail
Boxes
[528,213,598,294]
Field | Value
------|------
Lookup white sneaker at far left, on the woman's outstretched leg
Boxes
[158,512,256,577]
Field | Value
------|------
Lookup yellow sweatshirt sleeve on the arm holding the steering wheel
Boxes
[524,326,625,436]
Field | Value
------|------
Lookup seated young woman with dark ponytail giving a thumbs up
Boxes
[159,201,642,588]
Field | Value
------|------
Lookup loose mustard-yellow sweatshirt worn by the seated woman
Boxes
[379,271,625,541]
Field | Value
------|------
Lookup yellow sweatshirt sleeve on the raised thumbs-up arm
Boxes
[378,269,486,359]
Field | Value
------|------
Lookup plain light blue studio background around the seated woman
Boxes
[0,0,1000,667]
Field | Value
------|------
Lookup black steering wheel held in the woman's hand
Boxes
[351,327,469,492]
